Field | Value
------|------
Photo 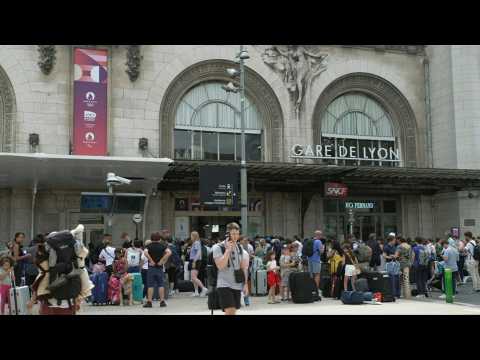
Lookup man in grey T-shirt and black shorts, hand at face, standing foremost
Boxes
[212,223,249,315]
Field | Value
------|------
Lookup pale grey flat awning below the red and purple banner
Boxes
[0,153,173,192]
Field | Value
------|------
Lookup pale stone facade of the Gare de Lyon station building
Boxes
[0,45,480,246]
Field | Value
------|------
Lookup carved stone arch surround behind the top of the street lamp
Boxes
[159,60,284,162]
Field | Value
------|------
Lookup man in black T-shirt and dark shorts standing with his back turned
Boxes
[143,232,172,308]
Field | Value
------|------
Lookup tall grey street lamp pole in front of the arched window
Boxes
[222,45,250,236]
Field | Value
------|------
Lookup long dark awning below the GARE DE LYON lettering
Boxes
[159,161,480,194]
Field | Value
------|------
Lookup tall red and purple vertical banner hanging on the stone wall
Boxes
[73,48,108,156]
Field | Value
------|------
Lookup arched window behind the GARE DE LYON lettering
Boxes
[321,92,400,166]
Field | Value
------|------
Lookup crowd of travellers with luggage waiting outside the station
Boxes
[0,223,480,314]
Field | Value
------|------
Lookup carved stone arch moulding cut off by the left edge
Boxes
[0,67,17,152]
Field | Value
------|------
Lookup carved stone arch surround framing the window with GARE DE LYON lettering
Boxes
[312,73,418,167]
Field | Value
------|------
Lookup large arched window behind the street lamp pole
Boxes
[174,82,263,161]
